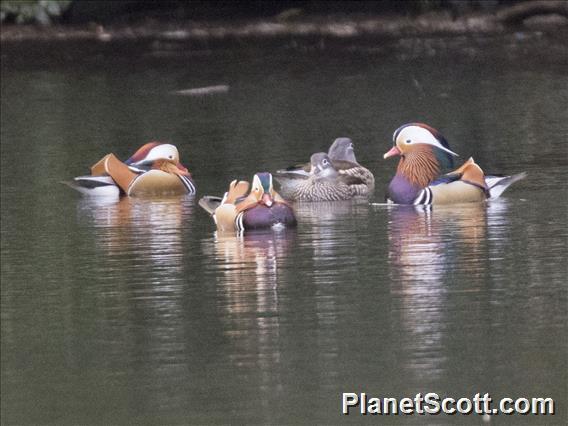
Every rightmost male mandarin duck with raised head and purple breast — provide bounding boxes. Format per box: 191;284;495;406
384;123;526;205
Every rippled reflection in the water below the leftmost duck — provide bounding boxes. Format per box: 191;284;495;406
78;196;194;412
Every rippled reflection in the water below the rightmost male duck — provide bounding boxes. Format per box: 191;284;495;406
388;200;507;380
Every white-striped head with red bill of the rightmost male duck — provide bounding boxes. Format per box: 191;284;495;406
384;123;458;168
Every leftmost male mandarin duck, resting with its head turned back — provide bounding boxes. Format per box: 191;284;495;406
70;142;195;196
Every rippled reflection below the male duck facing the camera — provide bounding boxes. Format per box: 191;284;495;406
204;229;296;400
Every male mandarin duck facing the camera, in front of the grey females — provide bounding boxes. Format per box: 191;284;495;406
199;172;296;232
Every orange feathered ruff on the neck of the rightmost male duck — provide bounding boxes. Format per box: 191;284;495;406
396;147;440;188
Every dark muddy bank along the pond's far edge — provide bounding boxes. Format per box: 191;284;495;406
0;2;568;43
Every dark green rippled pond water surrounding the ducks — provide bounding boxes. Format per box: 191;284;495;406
1;37;568;425
